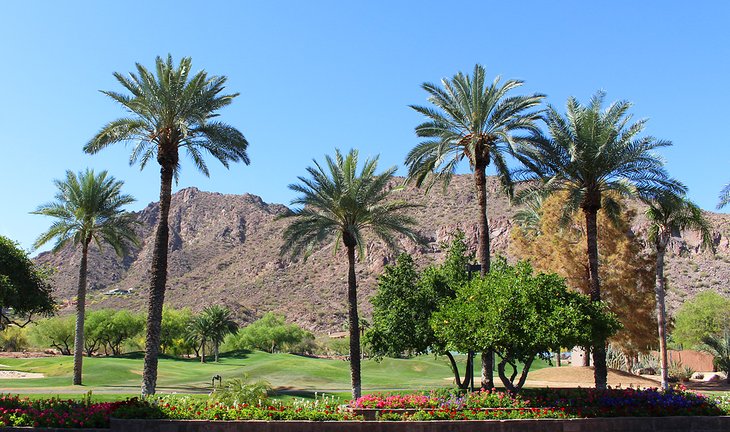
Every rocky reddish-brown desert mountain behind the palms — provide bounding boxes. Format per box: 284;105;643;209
37;176;730;331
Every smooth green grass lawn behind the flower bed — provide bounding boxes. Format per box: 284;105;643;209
0;351;547;397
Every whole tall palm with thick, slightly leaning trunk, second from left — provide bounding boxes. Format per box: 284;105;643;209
84;55;249;395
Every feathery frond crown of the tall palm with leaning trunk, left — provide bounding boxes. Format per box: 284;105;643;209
84;55;250;179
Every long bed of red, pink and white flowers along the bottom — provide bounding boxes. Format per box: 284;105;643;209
0;388;730;428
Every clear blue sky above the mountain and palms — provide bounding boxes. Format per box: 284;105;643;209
0;1;730;253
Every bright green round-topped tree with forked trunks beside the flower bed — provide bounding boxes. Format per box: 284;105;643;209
431;260;619;392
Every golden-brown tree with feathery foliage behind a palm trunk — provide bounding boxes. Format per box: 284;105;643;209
510;193;657;359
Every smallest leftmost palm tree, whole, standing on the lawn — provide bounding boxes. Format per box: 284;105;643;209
33;170;139;385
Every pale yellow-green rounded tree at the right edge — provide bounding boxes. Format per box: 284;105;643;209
671;291;730;348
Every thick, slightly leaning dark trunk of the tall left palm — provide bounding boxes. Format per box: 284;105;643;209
142;162;174;396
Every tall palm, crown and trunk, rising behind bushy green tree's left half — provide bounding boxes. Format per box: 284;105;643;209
406;64;545;388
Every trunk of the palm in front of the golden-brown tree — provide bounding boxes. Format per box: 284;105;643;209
583;207;608;389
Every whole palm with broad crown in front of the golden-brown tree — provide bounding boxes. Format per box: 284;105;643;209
518;92;683;388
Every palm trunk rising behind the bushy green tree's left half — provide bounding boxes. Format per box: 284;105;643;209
474;161;494;389
